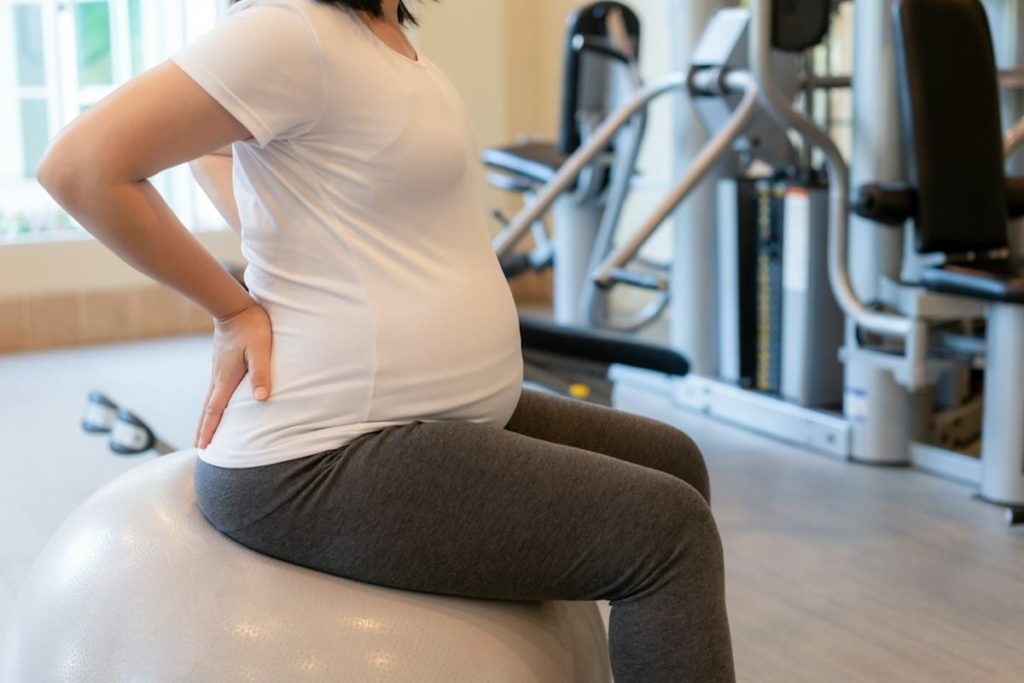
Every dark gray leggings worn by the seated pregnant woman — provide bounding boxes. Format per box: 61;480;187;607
196;390;734;683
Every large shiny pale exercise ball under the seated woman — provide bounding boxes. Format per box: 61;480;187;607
0;451;611;683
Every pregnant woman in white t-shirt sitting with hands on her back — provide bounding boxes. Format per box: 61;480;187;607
39;0;733;683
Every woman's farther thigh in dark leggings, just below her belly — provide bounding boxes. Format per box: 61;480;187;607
505;389;710;500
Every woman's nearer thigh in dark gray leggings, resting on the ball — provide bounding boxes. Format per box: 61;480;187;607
210;422;722;600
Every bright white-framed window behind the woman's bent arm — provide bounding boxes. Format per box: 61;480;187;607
0;0;227;242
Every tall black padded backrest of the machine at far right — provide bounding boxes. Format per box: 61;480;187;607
893;0;1009;253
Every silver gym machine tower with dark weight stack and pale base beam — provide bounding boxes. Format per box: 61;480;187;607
595;0;869;457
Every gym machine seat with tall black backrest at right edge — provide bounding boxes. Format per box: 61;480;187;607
855;0;1024;508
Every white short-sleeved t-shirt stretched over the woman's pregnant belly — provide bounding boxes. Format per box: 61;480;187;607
173;0;522;467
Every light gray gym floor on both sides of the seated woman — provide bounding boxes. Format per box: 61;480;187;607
0;335;1024;683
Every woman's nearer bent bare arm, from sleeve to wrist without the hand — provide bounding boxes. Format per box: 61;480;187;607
38;61;253;319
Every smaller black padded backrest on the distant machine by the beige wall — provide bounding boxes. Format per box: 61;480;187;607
558;0;640;155
